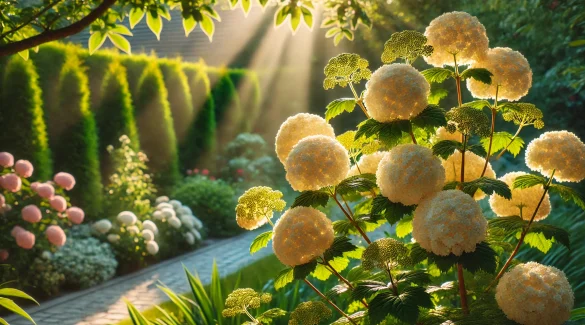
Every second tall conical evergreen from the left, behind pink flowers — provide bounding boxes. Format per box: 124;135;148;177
52;56;102;217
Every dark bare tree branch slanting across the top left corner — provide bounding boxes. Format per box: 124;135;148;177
0;0;116;57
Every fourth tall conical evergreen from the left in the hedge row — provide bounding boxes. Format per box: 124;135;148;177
134;61;179;192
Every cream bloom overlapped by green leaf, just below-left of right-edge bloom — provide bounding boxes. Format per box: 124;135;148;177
490;172;550;221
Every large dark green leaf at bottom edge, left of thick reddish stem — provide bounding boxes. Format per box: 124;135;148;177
368;287;434;324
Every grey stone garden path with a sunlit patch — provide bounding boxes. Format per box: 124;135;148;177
6;231;272;325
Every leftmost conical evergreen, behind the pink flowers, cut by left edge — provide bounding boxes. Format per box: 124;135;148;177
0;55;52;180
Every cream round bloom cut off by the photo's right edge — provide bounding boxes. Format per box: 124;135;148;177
526;131;585;182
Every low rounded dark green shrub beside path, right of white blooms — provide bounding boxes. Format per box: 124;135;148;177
172;176;240;237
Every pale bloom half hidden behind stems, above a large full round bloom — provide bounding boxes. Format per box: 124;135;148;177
443;150;496;200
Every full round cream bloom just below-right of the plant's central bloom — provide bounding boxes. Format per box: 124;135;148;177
412;190;487;256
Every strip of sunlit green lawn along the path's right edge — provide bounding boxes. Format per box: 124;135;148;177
116;255;284;325
